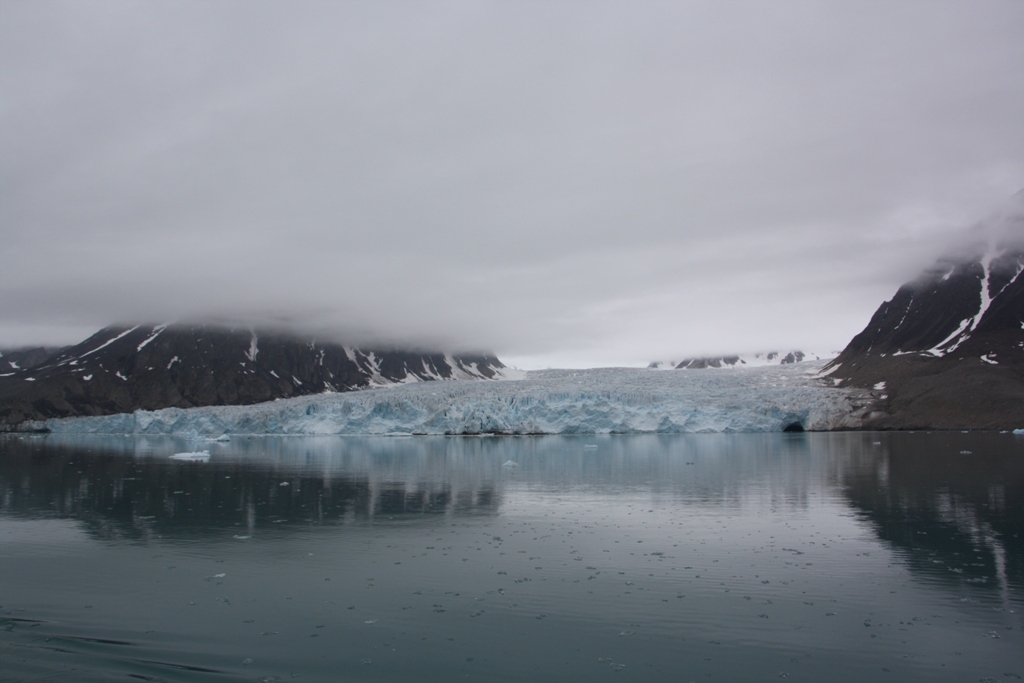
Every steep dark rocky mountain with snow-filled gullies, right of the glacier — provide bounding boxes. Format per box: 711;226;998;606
822;203;1024;429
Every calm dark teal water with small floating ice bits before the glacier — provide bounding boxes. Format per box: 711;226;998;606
0;433;1024;682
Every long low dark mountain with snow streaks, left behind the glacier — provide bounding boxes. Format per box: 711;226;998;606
0;325;505;429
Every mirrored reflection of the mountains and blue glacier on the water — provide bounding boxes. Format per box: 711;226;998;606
0;433;1024;588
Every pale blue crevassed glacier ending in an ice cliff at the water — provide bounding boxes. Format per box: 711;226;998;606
38;362;863;438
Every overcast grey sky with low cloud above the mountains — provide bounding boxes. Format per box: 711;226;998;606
0;0;1024;368
